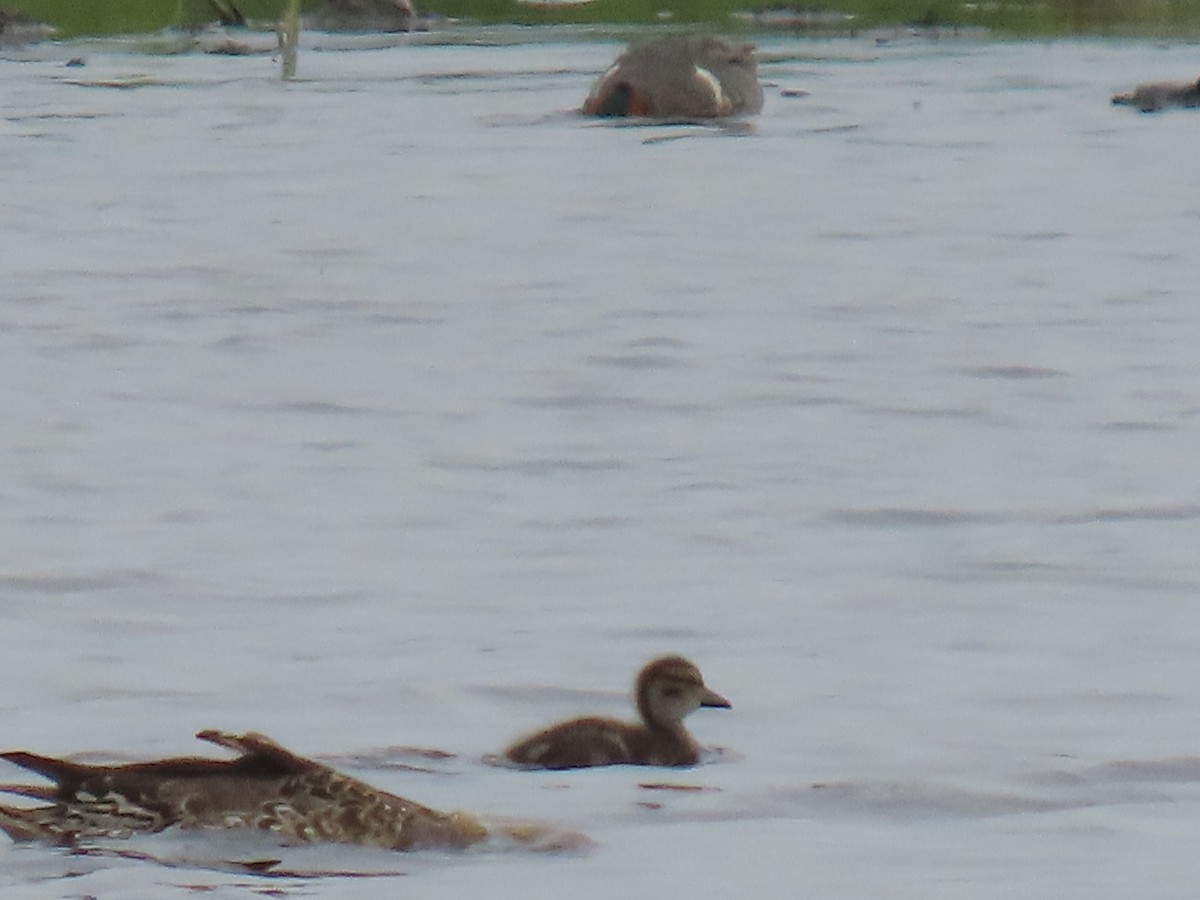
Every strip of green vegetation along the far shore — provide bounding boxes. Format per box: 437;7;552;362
11;0;1200;37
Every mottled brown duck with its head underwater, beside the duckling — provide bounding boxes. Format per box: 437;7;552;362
0;731;487;850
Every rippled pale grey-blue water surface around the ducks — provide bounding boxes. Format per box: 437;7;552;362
0;24;1200;900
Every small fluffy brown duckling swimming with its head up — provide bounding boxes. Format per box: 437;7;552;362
504;656;730;769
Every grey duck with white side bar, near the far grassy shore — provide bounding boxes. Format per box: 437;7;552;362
583;35;762;119
